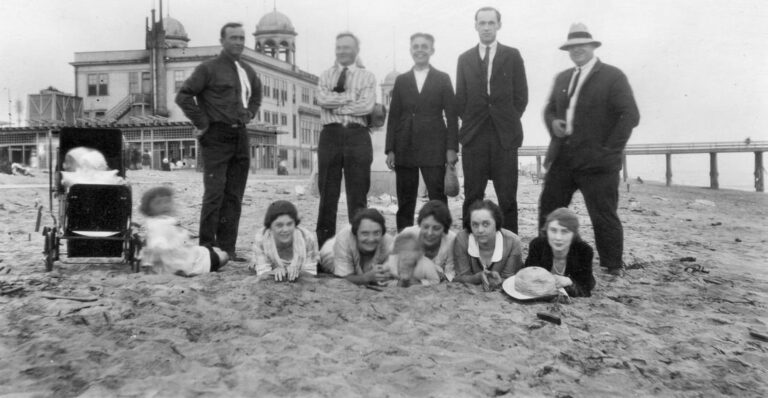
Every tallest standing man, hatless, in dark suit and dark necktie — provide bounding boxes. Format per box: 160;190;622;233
456;7;528;233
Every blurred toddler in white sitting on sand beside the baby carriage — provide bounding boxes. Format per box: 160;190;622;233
139;186;229;276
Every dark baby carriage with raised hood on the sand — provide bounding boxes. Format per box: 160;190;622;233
43;128;140;272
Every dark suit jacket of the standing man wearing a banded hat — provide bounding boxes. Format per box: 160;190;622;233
544;60;640;172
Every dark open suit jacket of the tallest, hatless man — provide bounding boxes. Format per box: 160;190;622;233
456;43;528;149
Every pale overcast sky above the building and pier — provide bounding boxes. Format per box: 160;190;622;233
0;0;768;145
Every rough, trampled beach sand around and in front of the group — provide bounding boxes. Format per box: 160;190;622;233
0;170;768;397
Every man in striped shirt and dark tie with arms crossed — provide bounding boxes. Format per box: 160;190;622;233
316;32;376;246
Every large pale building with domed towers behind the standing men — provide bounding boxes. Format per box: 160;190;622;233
63;4;321;174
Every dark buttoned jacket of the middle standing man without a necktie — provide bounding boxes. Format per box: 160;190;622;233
384;66;459;167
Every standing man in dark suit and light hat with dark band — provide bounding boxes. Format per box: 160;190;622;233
539;23;640;275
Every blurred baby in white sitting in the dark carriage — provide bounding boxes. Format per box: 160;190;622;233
61;146;125;188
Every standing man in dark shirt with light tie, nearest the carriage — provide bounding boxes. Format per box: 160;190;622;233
176;22;262;261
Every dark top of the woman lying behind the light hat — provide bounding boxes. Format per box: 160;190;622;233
525;237;595;297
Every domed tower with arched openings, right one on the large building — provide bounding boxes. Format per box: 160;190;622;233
253;9;297;65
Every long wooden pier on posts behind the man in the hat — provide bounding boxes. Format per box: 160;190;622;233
518;140;768;192
